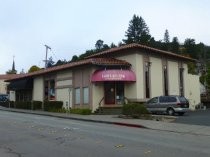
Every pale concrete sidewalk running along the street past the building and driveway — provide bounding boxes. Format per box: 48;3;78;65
0;107;210;136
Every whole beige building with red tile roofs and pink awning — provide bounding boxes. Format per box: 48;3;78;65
8;44;200;111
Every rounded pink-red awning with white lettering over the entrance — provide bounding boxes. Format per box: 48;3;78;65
91;69;136;82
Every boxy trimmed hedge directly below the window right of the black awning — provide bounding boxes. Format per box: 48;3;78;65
44;101;63;111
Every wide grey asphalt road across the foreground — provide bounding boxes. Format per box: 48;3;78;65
0;111;210;157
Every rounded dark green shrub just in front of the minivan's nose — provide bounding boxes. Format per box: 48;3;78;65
122;103;149;118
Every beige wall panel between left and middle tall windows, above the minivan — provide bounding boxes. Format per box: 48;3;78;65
150;57;163;97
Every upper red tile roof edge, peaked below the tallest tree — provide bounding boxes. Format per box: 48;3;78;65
86;43;196;61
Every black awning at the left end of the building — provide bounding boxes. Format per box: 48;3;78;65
7;79;33;90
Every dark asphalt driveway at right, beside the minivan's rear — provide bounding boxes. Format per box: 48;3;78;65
175;109;210;126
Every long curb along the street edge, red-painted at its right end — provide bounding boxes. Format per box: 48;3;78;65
0;107;149;129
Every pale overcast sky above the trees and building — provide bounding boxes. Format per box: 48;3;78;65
0;0;210;74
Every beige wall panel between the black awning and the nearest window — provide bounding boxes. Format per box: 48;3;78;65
33;76;44;101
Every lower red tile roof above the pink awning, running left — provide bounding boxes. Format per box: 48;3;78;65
6;58;131;82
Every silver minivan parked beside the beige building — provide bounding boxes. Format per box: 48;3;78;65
145;95;189;115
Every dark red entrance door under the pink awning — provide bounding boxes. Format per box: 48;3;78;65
104;82;115;104
